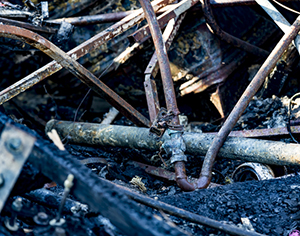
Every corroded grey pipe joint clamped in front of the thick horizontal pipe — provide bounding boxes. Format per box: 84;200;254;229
162;129;187;163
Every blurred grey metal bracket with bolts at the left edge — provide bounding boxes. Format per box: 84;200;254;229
0;124;36;213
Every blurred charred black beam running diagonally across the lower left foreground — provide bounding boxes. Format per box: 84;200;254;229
0;113;186;236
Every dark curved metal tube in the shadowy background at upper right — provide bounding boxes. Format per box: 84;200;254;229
202;0;269;58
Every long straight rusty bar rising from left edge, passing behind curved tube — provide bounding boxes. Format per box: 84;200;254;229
0;0;174;105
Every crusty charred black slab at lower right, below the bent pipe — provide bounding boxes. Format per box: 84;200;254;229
159;176;300;235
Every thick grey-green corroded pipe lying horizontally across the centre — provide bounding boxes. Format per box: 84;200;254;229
46;120;300;166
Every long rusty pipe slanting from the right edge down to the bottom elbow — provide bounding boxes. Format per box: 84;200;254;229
197;14;300;188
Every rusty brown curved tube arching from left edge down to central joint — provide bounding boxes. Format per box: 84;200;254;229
0;25;150;127
